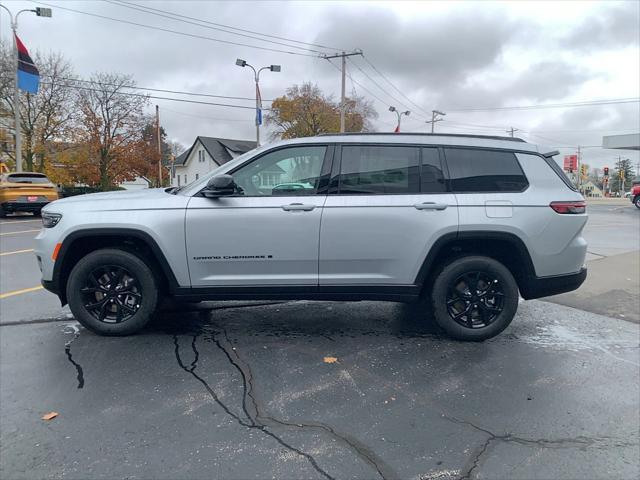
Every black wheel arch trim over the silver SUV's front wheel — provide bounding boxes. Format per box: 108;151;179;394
52;228;178;305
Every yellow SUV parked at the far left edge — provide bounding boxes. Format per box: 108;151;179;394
0;172;58;217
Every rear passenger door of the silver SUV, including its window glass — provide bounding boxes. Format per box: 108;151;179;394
319;144;458;287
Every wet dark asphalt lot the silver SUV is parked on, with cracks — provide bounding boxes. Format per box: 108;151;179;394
0;205;640;479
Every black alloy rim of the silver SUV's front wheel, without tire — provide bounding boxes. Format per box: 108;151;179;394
80;265;143;323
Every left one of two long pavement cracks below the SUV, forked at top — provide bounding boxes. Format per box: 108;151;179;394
173;334;335;480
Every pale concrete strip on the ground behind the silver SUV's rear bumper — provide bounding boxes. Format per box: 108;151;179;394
543;250;640;323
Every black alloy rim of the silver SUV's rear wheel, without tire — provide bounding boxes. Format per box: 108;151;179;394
447;271;505;329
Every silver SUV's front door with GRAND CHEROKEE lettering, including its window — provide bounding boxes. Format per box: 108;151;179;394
186;145;328;287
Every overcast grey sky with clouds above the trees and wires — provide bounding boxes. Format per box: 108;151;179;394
0;0;640;167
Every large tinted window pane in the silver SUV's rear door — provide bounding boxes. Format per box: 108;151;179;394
340;146;420;194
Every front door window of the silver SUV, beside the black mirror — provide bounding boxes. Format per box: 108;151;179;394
233;146;327;196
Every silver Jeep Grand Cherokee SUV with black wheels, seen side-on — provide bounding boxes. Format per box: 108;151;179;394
35;134;587;340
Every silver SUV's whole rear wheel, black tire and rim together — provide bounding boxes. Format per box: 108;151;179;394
431;256;518;341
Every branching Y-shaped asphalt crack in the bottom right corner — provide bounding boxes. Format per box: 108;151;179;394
452;415;637;480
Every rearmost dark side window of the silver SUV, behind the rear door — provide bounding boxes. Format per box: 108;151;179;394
445;148;528;192
